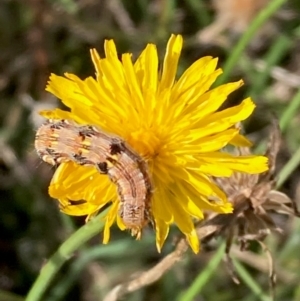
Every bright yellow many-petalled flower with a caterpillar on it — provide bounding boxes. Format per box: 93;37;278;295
42;35;267;252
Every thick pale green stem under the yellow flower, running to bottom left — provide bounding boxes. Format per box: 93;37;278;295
25;211;106;301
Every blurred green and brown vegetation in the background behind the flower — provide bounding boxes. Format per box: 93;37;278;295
0;0;300;301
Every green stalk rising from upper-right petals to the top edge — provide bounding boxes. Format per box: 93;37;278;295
216;0;287;85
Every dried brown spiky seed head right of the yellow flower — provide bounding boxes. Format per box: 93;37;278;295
215;122;299;287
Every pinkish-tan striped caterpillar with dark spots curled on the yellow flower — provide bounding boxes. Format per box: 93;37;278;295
35;120;153;238
